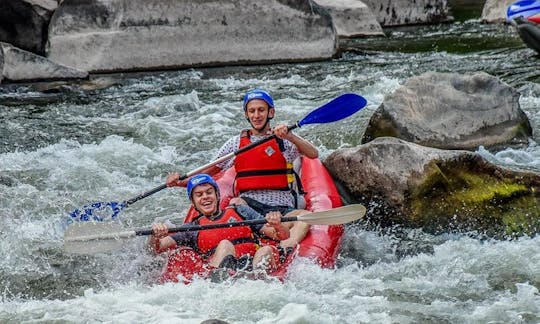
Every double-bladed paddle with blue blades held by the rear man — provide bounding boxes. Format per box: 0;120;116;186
69;93;367;221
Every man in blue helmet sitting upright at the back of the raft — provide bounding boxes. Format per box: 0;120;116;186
167;89;318;250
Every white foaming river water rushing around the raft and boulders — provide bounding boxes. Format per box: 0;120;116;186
0;21;540;323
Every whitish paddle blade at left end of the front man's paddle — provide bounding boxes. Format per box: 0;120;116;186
64;222;136;254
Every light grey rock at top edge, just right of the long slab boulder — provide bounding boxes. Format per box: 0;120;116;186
315;0;384;37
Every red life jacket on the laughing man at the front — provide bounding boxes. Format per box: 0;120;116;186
196;208;259;256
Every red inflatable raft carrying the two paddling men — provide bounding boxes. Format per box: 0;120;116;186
160;157;344;283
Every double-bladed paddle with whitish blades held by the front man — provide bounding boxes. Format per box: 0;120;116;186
64;204;366;254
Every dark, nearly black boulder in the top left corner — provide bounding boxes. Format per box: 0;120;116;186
0;0;57;55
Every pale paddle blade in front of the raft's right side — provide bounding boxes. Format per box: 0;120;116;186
298;204;366;225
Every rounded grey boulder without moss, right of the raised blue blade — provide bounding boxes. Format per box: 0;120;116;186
362;72;532;150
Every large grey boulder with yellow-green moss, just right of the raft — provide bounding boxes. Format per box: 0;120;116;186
324;137;540;237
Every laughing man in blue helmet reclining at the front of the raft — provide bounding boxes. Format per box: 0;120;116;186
149;174;290;280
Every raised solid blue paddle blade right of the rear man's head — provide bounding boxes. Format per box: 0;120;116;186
297;93;367;127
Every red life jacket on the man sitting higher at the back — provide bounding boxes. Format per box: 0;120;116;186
234;130;294;195
